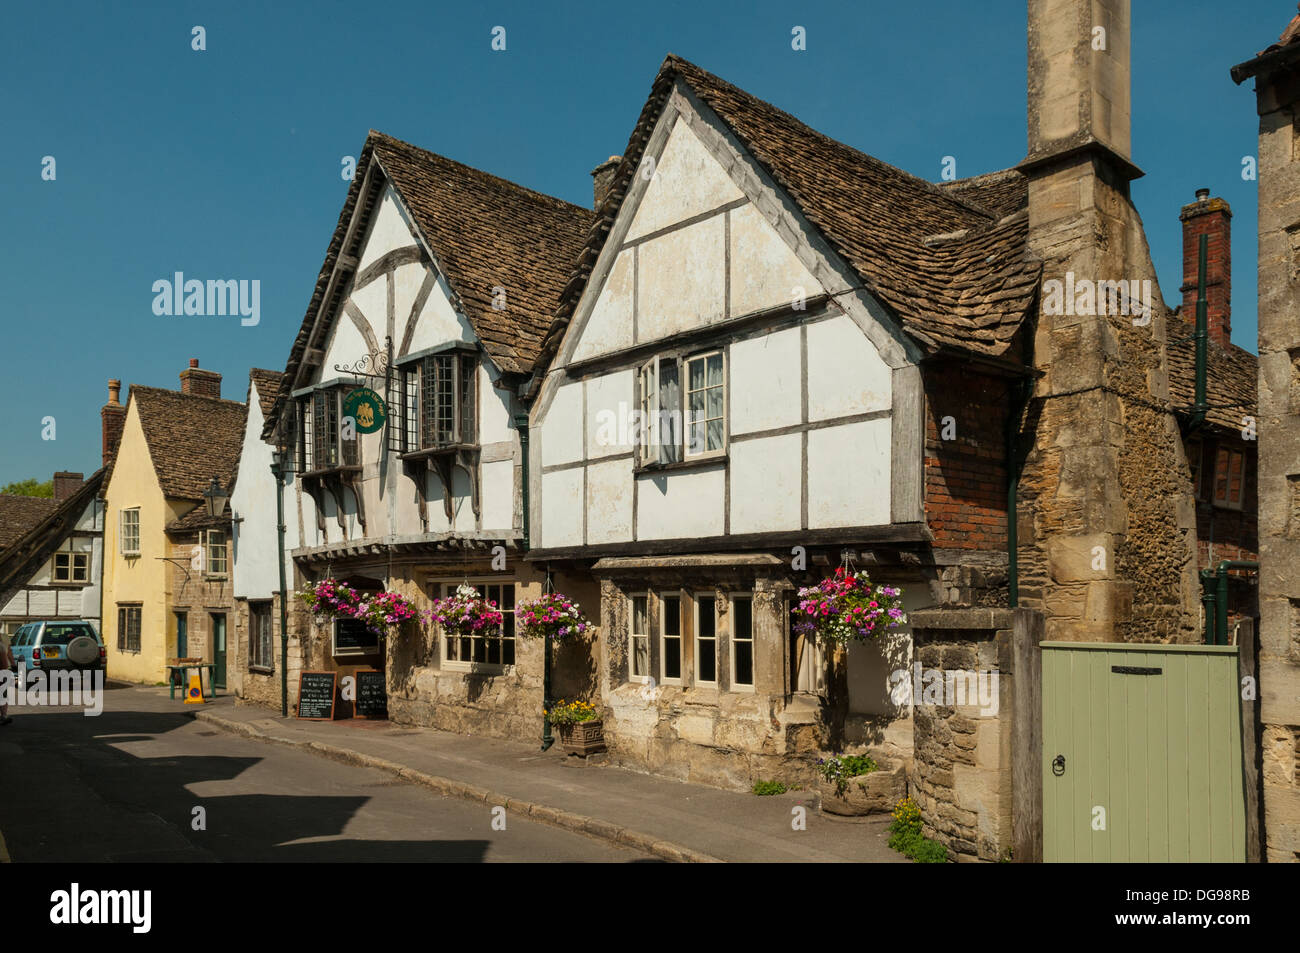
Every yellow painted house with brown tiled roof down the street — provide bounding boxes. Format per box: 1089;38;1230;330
103;360;247;684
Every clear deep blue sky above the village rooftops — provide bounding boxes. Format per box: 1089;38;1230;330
0;0;1295;485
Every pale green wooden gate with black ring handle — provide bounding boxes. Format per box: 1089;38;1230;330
1041;642;1245;862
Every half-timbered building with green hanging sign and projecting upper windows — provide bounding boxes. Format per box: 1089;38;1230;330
260;131;594;737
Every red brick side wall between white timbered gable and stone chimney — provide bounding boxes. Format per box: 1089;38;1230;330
924;363;1010;550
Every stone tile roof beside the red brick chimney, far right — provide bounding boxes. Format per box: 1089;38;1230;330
1169;313;1260;432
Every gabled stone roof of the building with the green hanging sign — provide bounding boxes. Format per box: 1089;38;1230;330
263;130;594;437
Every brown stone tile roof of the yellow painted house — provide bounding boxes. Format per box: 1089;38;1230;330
127;385;248;501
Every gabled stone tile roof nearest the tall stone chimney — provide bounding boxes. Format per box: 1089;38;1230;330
533;55;1041;374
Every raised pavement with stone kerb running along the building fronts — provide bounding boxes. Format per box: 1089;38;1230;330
189;689;909;863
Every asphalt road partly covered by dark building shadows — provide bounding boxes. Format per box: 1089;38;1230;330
0;685;650;863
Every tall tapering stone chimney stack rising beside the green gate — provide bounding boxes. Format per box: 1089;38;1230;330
1017;0;1200;642
